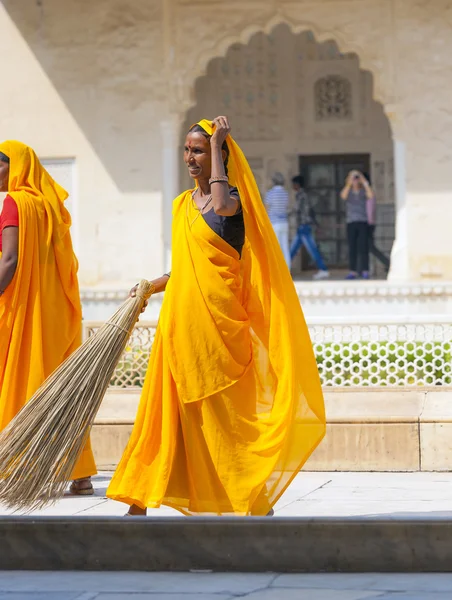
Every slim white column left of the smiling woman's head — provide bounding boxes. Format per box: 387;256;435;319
160;114;183;272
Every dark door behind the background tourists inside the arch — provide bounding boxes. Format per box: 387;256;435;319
299;154;370;270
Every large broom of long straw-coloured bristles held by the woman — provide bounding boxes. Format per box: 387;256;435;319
0;280;155;511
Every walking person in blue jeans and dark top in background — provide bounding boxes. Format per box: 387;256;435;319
290;175;330;279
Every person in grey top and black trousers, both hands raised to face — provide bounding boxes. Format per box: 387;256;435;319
341;171;374;279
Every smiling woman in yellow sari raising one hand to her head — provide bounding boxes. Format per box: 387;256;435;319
107;117;325;515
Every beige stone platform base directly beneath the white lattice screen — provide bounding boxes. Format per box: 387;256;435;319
91;388;452;471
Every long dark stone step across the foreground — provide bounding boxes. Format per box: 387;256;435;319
0;516;452;573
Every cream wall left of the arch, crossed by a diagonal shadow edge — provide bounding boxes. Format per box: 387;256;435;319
0;0;165;287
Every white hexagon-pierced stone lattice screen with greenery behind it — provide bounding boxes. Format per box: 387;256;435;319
85;323;452;388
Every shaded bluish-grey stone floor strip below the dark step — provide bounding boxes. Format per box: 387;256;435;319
0;571;452;600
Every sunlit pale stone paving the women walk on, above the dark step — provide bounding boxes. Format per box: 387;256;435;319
0;472;452;516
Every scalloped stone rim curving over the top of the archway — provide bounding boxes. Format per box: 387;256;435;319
175;13;394;116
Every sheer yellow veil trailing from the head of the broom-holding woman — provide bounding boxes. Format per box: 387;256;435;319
198;120;326;504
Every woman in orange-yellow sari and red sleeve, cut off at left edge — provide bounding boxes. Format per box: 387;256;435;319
0;141;96;495
